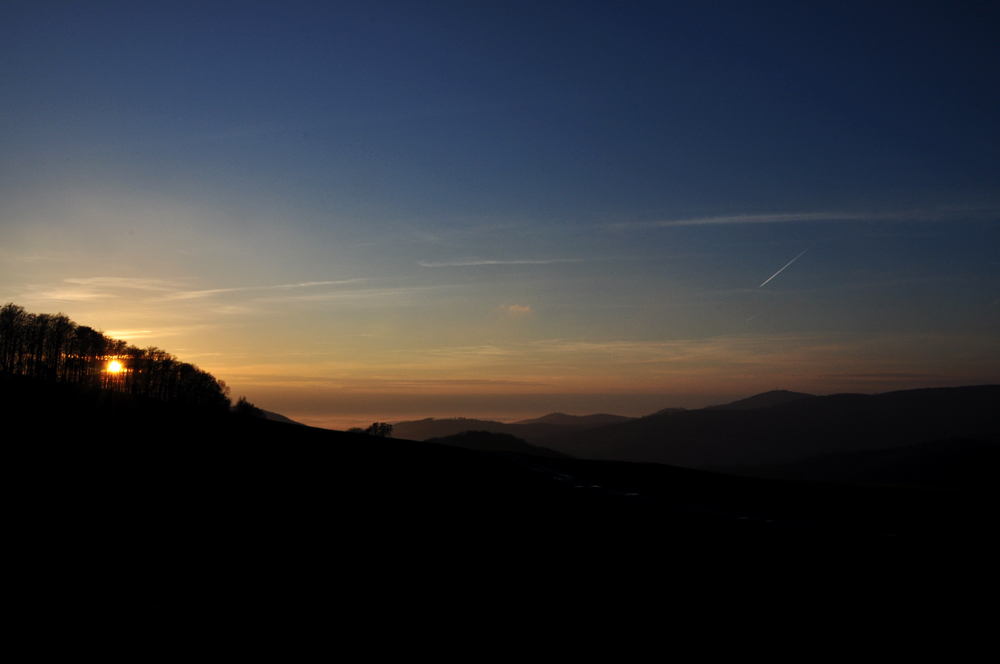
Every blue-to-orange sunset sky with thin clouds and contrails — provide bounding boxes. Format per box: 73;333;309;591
0;1;1000;428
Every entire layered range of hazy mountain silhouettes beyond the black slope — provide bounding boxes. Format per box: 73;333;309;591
395;385;1000;491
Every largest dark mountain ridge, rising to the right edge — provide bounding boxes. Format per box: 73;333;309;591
536;385;1000;468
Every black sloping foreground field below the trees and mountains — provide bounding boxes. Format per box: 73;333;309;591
0;377;997;658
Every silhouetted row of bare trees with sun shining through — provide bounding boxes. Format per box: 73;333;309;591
0;302;230;410
